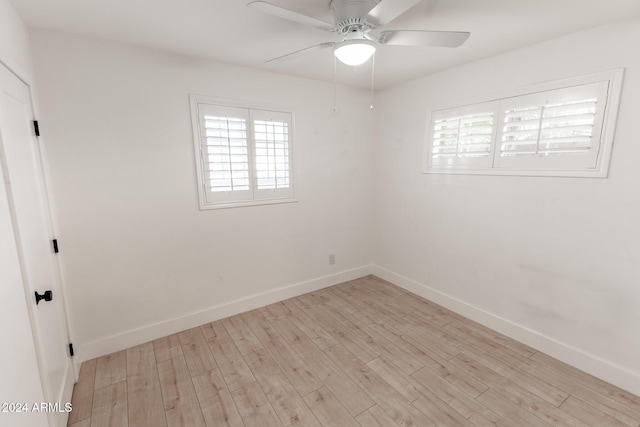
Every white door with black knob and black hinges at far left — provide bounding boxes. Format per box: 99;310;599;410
0;61;73;426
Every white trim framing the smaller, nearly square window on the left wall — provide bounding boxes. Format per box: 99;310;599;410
189;94;298;210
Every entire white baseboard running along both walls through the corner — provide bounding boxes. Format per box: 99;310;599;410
74;264;640;395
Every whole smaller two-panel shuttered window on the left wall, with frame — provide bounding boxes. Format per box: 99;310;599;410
190;95;295;209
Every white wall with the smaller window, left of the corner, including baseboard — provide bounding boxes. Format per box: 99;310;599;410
32;31;373;360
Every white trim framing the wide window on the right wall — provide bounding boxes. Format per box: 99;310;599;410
422;68;624;178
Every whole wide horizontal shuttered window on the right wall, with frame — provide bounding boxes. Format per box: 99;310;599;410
425;70;622;177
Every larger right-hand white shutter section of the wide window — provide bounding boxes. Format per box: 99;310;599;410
495;82;608;170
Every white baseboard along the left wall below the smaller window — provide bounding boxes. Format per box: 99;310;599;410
74;265;371;374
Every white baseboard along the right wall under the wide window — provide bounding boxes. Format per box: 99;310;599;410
371;264;640;396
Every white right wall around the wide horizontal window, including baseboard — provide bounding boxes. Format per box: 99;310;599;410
373;19;640;394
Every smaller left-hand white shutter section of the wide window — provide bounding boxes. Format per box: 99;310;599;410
429;103;495;168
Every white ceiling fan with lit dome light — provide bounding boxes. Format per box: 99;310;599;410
248;0;470;66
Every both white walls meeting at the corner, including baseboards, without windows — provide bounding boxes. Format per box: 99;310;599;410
32;15;640;394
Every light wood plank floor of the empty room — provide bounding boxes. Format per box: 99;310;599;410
69;276;640;427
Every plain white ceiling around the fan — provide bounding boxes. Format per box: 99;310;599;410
10;0;640;88
